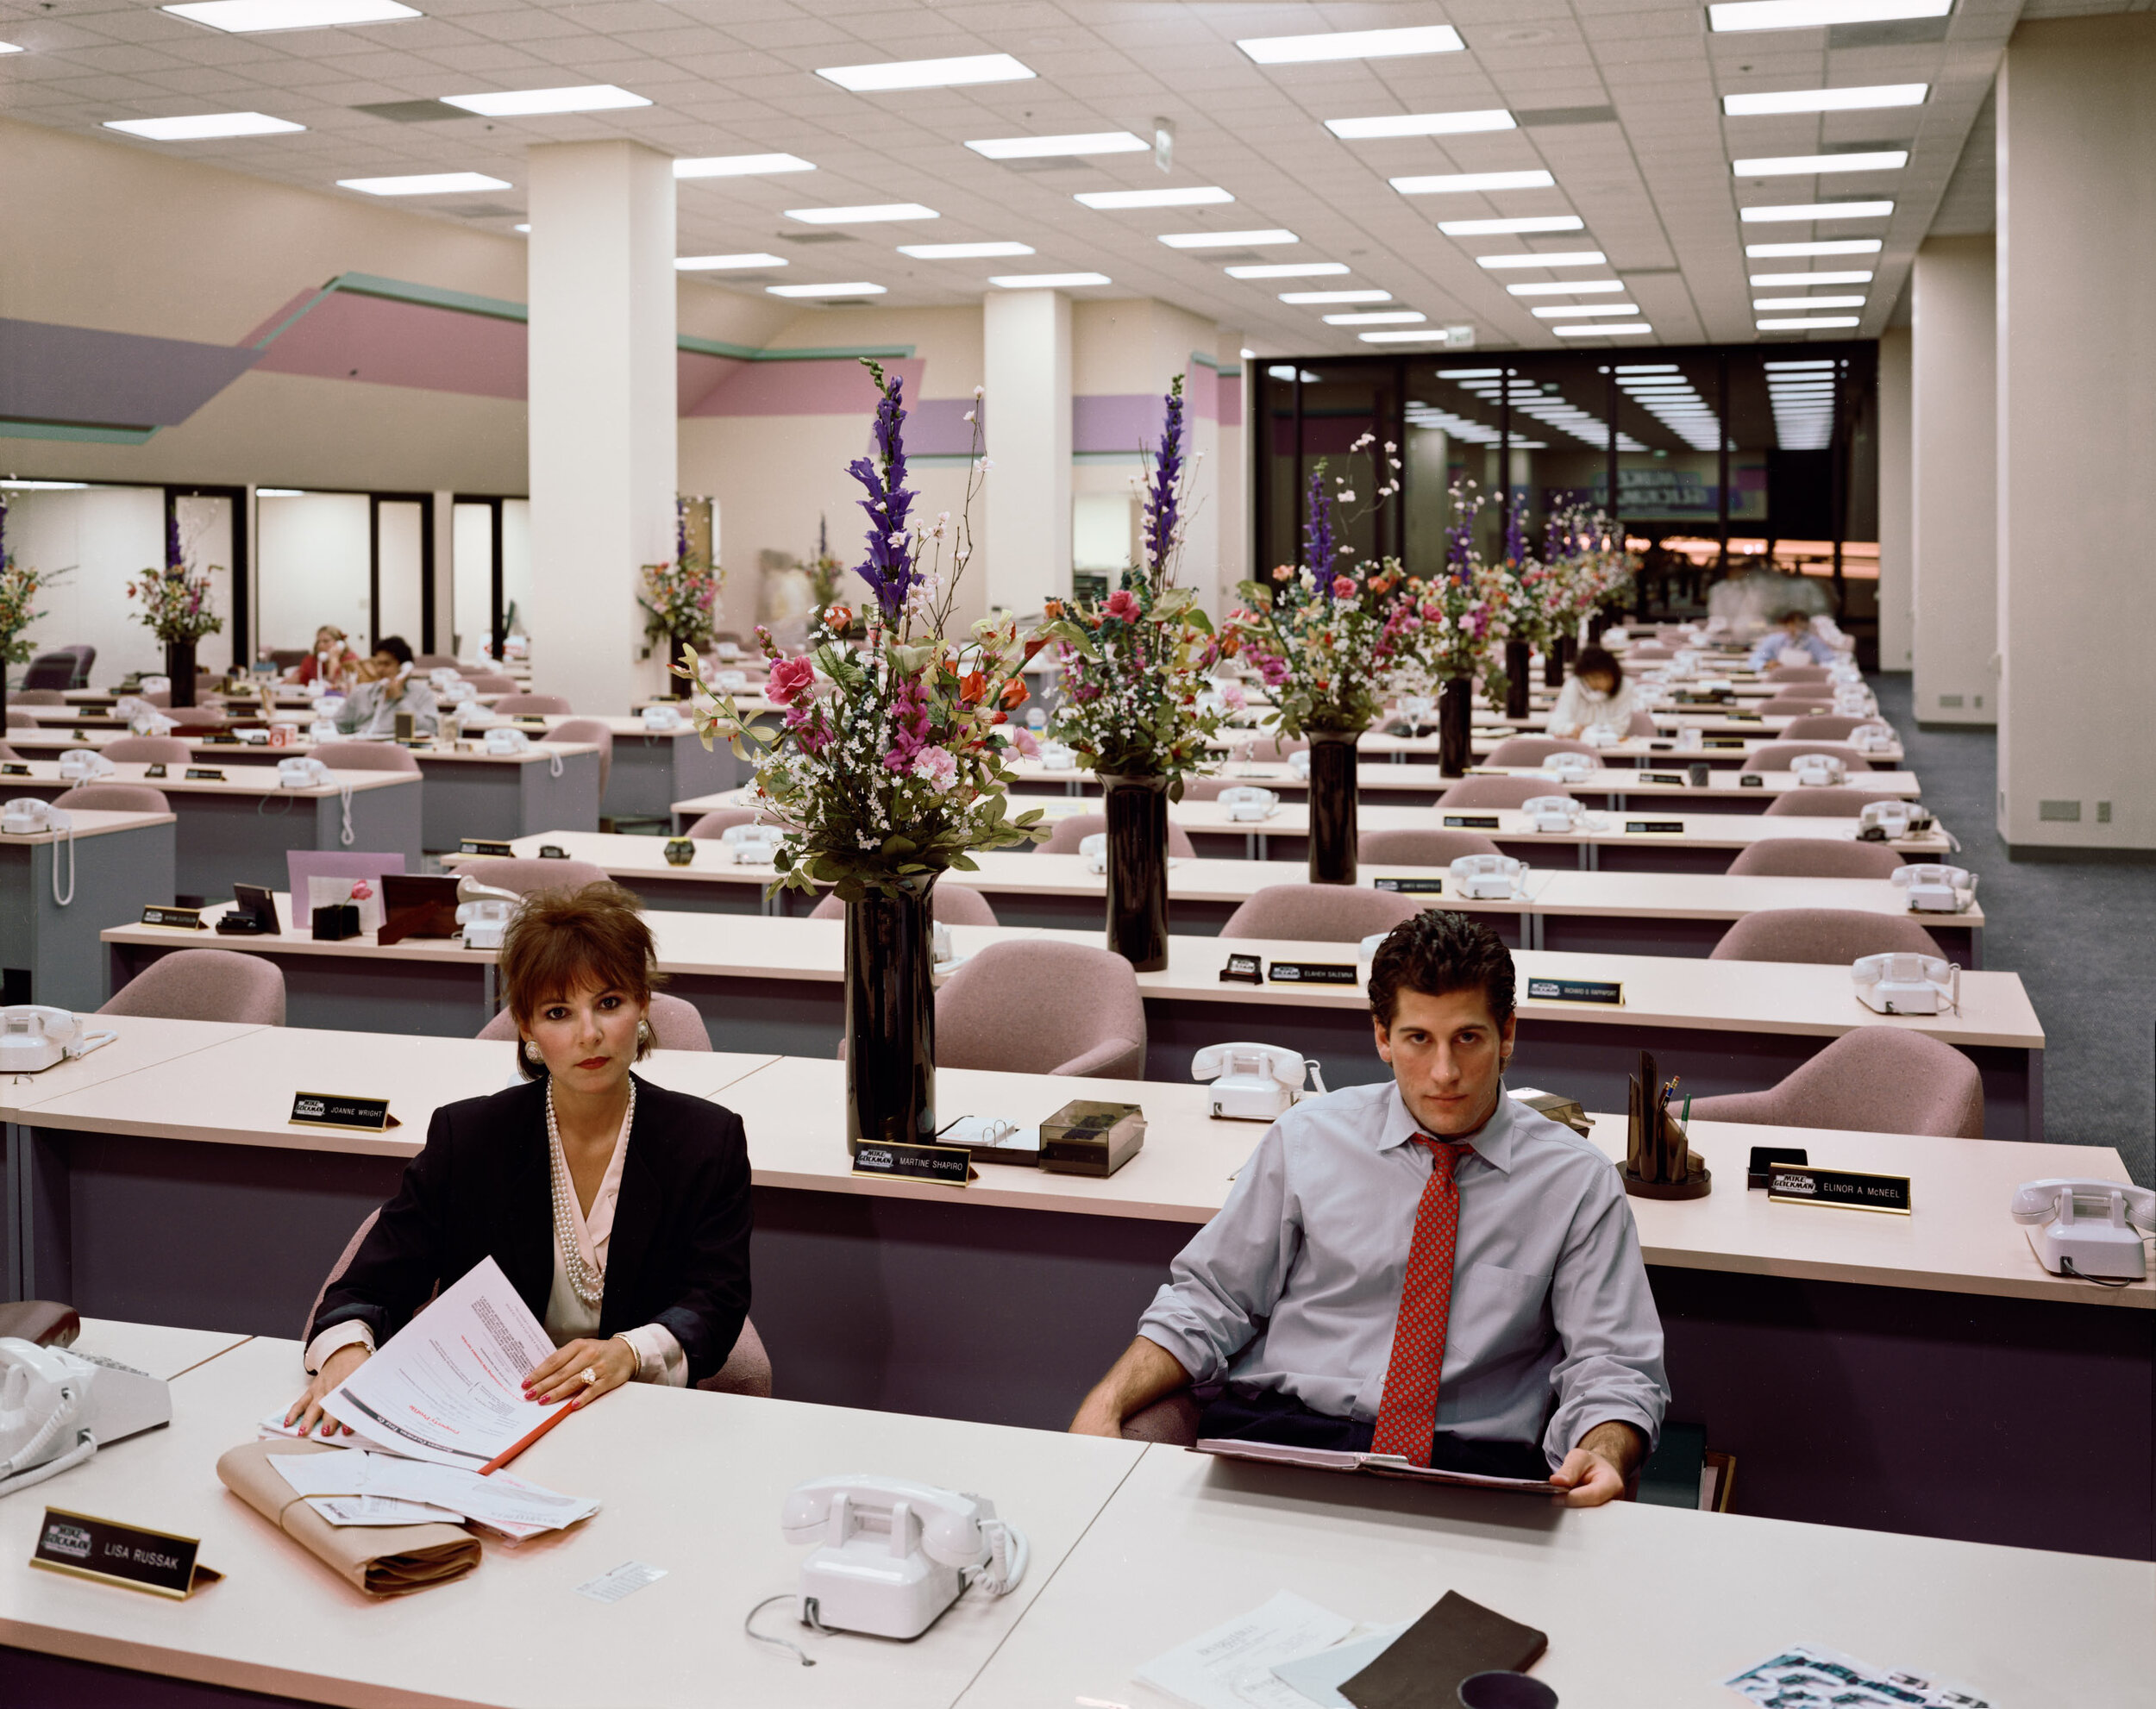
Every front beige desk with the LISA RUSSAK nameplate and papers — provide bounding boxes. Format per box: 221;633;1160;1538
0;1341;1143;1709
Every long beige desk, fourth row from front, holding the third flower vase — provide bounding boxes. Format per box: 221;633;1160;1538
442;832;1984;967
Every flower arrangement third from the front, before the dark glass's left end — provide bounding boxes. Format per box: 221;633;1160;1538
1223;433;1414;737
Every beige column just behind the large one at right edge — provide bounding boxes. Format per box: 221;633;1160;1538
1915;235;1999;724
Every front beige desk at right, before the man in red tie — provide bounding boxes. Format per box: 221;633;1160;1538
960;1446;2156;1709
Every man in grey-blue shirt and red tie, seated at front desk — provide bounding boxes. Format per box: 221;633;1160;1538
1072;910;1669;1506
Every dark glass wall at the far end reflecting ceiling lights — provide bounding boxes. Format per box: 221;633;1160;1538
1250;342;1878;653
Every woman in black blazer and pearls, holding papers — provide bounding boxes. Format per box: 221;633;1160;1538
285;884;750;1433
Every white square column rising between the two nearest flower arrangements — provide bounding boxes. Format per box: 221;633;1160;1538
981;291;1072;617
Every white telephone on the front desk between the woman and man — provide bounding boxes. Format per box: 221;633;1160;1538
779;1476;1031;1638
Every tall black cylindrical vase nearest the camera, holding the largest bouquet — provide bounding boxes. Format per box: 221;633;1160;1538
845;880;936;1155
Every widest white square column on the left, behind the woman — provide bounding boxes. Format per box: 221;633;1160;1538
526;140;677;716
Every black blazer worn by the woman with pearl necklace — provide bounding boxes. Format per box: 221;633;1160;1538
309;1078;750;1384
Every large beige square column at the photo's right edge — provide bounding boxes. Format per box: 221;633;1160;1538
1992;13;2156;851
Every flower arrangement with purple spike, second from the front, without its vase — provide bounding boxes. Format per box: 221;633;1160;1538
1044;375;1240;799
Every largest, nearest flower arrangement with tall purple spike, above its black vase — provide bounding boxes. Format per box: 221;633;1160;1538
675;358;1048;903
